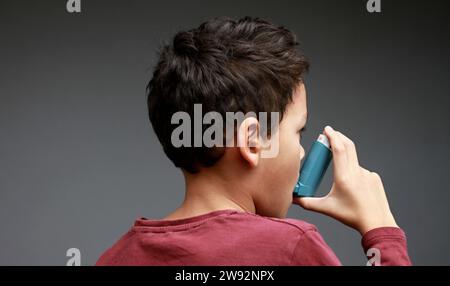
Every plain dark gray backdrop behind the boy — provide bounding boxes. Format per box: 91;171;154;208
0;0;450;265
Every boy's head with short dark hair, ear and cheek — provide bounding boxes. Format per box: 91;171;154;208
148;17;309;217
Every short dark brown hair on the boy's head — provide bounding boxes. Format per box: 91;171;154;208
147;17;309;173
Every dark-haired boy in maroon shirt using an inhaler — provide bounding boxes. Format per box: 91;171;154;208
97;17;410;265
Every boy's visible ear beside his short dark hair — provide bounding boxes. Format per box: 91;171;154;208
237;117;261;167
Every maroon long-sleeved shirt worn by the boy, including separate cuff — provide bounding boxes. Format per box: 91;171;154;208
96;210;411;265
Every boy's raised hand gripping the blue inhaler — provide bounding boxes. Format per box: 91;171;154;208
293;126;398;235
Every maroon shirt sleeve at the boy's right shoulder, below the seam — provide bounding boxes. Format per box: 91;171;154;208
292;229;341;266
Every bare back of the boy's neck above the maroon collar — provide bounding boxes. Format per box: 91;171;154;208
164;170;255;220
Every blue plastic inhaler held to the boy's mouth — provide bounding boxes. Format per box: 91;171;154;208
294;134;333;197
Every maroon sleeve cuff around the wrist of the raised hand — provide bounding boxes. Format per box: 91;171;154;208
361;227;411;266
